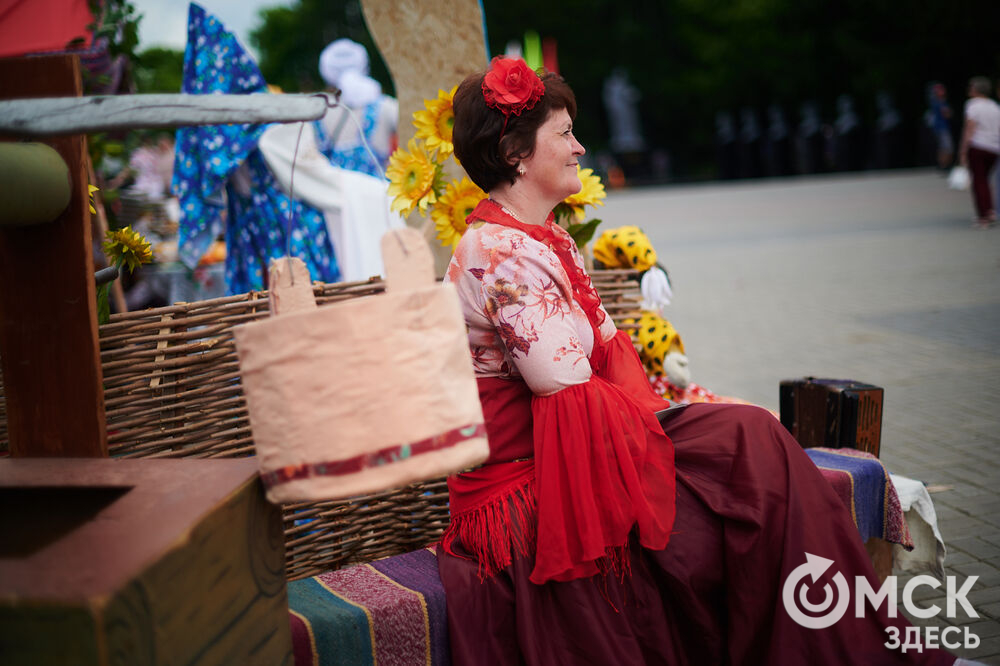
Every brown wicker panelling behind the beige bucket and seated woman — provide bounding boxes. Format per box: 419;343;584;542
0;270;639;580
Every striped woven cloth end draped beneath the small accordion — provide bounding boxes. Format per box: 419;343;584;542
806;448;913;550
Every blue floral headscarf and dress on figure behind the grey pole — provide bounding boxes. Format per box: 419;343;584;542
173;3;340;294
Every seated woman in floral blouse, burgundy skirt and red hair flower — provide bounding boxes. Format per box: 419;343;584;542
439;58;955;666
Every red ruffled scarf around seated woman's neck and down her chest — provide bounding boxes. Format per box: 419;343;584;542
466;199;605;332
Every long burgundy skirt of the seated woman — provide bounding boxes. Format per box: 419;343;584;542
438;404;955;666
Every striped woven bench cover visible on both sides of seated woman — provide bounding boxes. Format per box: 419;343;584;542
288;448;913;666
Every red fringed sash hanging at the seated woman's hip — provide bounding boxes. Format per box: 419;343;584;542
441;478;538;581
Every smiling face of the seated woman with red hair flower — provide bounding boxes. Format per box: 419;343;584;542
520;109;586;206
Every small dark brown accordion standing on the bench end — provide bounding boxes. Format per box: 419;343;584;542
779;377;884;457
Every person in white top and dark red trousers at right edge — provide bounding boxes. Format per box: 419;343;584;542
959;76;1000;229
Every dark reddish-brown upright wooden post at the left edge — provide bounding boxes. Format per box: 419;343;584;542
0;55;108;457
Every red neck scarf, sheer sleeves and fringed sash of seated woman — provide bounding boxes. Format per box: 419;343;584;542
442;200;674;584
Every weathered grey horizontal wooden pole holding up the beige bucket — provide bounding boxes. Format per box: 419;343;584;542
0;93;335;136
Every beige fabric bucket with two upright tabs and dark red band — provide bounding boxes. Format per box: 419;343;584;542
234;228;489;502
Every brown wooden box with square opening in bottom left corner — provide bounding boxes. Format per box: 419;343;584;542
0;458;292;666
